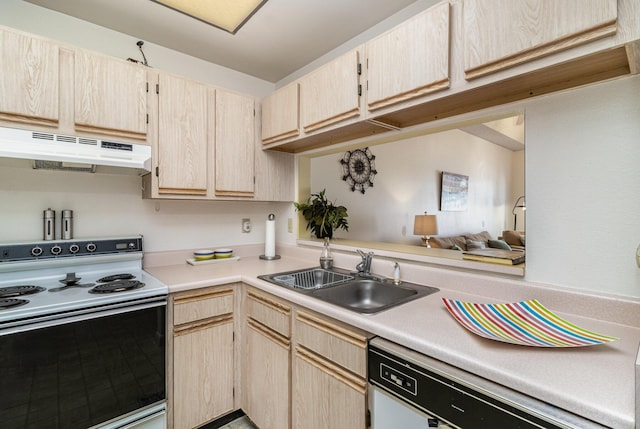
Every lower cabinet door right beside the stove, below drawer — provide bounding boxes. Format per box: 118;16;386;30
173;316;234;429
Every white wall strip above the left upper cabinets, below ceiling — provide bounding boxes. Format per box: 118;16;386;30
0;0;274;97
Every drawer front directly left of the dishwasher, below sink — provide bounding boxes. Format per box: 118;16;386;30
296;311;367;377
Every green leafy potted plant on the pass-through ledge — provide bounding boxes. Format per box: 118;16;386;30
293;189;349;238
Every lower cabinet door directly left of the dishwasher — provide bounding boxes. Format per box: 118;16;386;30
293;348;367;429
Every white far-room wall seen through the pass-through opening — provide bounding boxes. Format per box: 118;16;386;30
311;130;524;244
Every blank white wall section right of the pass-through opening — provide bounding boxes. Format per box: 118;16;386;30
525;76;640;297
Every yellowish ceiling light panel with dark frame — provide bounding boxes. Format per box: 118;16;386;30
151;0;267;34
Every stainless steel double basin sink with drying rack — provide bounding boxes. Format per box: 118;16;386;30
258;268;438;314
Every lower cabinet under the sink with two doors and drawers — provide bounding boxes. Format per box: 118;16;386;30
242;285;370;429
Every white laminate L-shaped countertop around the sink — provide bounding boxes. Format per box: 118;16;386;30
145;246;640;429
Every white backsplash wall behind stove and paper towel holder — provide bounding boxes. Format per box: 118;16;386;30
0;160;295;251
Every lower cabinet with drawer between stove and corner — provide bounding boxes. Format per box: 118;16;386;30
167;285;235;429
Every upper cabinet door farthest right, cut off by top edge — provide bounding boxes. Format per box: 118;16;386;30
463;0;618;79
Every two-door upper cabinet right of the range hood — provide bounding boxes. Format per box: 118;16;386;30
142;71;294;201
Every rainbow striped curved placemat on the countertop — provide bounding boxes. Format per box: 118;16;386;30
442;298;619;347
